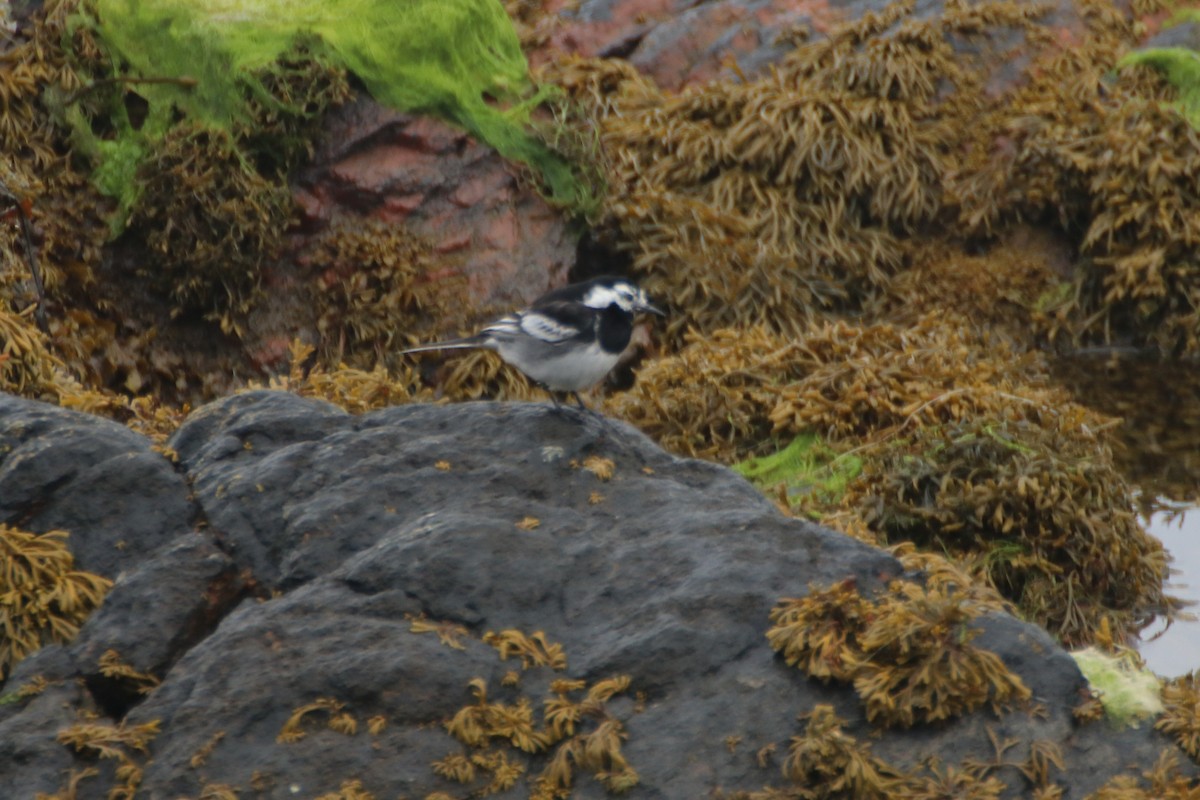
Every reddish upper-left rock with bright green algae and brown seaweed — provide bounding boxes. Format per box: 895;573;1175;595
0;0;578;405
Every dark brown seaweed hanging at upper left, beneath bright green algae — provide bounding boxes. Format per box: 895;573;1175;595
0;0;349;395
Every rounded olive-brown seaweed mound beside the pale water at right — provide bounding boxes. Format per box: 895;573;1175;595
844;417;1176;644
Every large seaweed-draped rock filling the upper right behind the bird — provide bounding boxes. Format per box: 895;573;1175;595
545;0;1198;354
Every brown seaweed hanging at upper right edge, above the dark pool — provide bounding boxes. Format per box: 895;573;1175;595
956;1;1200;355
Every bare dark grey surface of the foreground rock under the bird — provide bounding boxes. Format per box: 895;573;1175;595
0;392;1187;799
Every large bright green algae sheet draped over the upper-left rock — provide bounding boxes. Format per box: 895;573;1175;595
64;0;584;212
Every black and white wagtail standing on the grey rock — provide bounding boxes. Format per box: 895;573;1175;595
401;276;665;409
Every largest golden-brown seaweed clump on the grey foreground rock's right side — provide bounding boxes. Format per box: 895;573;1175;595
767;581;1030;727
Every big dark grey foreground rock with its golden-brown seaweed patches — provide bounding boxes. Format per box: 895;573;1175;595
0;392;1194;800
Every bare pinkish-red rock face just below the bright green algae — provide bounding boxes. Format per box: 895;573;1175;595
288;98;575;308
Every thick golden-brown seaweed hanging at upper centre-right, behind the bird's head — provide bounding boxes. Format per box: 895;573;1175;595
547;2;1038;342
